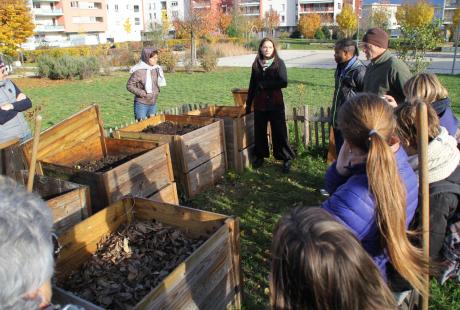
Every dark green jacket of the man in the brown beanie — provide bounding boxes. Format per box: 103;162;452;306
364;50;412;104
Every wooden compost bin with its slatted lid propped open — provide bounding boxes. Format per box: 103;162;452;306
23;105;174;212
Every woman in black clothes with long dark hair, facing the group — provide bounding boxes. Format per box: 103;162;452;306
246;38;294;173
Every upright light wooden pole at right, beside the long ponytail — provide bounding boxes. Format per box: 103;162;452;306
417;101;430;310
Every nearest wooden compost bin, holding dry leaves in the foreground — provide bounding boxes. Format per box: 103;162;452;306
56;198;241;310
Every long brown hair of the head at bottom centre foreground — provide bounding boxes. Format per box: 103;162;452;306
270;208;396;310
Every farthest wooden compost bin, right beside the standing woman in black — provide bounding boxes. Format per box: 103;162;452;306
187;106;254;172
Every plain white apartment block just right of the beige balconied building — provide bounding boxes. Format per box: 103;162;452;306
106;0;144;42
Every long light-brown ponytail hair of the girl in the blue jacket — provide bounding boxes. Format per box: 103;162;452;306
338;93;428;294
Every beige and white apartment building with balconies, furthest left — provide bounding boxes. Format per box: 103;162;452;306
24;0;107;49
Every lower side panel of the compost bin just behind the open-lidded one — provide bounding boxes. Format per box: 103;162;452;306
185;154;225;198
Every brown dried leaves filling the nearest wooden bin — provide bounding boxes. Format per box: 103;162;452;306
58;220;204;309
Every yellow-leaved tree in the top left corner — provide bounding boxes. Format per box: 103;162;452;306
0;0;35;56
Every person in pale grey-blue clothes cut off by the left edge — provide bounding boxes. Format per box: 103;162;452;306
0;60;32;143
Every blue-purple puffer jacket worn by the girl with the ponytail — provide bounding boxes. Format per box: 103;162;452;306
322;147;418;279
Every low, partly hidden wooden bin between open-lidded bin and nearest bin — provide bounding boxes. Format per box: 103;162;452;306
15;170;91;235
